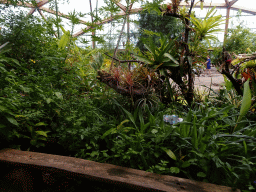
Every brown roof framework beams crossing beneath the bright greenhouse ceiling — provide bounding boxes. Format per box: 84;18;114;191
0;0;256;47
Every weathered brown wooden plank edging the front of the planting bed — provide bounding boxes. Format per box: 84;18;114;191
0;149;240;192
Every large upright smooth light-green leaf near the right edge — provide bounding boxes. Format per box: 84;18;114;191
237;79;252;122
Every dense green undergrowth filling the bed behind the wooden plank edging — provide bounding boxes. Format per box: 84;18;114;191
0;9;256;191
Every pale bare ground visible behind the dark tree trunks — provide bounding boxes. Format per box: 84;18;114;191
195;67;224;92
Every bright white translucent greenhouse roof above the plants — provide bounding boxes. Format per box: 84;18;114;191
0;0;256;48
